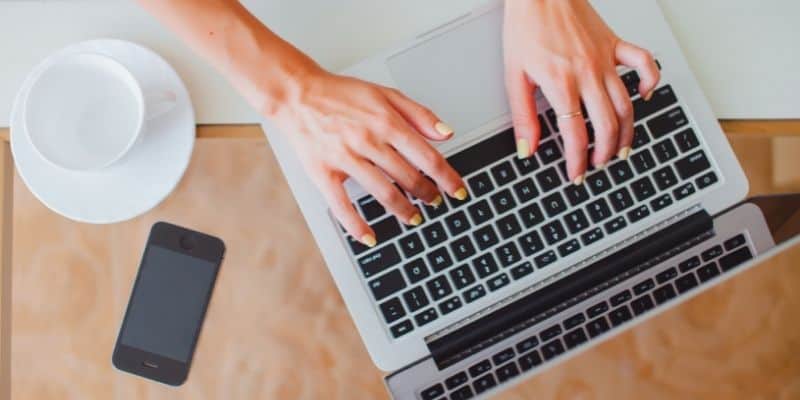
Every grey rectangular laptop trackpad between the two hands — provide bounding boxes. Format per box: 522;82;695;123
387;8;509;133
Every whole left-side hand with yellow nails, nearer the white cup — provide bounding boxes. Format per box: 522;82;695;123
267;68;467;247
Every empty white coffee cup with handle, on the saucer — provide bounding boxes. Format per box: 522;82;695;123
23;53;176;171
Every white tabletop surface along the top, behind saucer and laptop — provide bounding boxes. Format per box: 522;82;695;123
0;0;800;126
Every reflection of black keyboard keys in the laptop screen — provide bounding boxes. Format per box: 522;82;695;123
419;234;753;400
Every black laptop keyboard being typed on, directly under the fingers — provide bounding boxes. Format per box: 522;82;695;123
343;71;718;338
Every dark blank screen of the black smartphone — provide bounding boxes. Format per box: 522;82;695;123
120;245;216;363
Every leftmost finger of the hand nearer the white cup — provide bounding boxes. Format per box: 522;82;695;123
312;167;376;247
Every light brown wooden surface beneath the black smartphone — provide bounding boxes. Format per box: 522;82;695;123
0;121;800;400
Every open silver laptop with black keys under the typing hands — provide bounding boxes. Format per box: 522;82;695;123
263;0;792;400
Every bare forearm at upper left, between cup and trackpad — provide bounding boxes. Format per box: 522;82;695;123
138;0;319;115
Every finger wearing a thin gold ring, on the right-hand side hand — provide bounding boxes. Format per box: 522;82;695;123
539;77;589;185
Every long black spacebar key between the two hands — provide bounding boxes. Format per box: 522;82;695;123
447;129;516;176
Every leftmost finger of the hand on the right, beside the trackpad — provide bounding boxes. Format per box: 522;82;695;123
506;71;541;158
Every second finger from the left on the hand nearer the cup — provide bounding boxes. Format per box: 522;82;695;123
345;158;422;226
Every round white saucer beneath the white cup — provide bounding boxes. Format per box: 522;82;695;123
11;39;195;224
